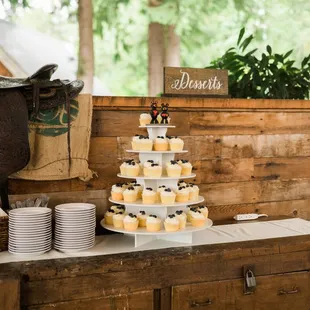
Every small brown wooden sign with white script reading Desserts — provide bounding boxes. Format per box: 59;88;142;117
164;67;228;96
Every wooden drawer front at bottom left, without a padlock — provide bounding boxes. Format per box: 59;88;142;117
27;291;153;310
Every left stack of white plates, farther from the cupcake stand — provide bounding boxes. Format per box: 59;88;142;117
9;207;52;255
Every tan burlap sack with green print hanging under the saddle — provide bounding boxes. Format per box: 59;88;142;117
11;95;93;181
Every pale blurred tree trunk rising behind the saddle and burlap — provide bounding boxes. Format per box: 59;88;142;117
77;0;94;94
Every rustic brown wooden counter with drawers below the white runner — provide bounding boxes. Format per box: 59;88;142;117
0;219;310;310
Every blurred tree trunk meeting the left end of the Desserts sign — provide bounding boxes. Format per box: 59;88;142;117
148;23;165;96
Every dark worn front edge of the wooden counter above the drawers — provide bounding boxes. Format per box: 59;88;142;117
0;235;310;281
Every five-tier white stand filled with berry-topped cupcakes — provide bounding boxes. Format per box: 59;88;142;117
101;109;212;247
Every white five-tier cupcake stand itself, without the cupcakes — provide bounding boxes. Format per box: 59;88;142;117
101;125;213;247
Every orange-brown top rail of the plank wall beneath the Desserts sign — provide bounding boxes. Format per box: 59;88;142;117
93;96;310;111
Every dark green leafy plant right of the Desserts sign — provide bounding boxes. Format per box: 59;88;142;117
209;28;310;99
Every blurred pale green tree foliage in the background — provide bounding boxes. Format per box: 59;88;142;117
0;0;310;96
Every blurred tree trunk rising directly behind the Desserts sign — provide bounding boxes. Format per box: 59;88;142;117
165;25;181;67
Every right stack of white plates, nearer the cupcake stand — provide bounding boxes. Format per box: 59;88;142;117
54;203;96;252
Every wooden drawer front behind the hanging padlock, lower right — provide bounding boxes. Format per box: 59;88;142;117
172;272;310;310
